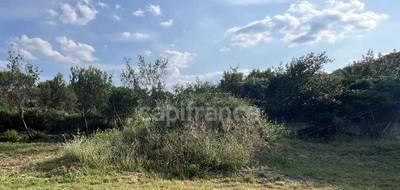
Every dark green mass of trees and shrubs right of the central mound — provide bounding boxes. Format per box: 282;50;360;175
219;51;400;138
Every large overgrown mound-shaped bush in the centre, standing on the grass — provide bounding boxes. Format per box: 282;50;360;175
66;92;280;178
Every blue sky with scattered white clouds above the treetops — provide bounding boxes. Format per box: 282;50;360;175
0;0;400;86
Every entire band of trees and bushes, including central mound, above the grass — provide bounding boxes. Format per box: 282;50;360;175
0;49;400;178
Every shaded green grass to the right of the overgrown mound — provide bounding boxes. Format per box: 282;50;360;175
263;140;400;189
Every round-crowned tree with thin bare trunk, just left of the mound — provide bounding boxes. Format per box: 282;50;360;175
71;66;112;135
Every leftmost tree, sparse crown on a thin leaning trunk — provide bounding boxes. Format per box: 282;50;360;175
0;51;39;138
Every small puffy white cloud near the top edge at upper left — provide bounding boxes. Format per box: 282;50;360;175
59;3;98;26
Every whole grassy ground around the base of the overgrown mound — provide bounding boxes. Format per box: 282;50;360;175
0;140;400;189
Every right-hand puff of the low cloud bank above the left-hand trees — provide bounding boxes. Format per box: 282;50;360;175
57;36;97;62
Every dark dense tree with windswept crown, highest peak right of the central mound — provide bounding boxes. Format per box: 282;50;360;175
264;53;332;121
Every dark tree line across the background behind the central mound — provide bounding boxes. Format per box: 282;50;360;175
0;51;400;138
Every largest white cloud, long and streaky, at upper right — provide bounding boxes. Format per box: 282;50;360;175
227;0;388;47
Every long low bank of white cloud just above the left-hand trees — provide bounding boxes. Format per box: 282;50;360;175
12;34;97;65
